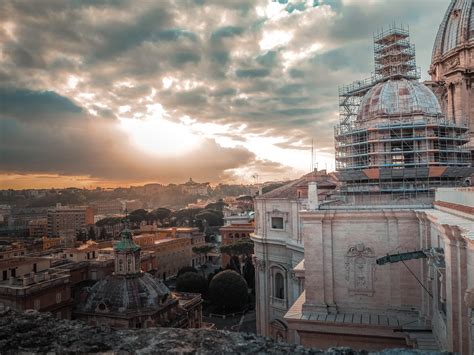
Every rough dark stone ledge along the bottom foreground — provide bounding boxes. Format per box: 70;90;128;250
0;311;446;355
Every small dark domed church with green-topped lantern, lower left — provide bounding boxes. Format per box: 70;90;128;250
74;222;202;328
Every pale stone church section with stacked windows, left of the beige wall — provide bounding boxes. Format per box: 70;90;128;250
251;170;337;341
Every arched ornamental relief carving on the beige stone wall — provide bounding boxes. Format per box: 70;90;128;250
345;242;375;296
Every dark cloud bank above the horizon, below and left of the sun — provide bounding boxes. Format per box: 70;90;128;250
0;90;254;181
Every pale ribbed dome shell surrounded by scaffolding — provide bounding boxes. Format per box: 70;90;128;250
357;79;441;120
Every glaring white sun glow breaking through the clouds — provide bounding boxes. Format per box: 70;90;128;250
120;104;202;156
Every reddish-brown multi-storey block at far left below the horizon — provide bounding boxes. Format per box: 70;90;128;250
47;204;94;237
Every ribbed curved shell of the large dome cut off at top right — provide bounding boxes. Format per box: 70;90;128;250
433;0;474;62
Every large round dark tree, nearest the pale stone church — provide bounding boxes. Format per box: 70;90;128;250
209;270;248;312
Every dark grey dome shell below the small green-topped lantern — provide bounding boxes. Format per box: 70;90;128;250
79;273;171;314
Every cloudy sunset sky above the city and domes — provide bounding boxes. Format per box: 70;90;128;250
0;0;449;189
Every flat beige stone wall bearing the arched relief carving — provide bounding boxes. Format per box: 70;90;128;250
302;210;421;312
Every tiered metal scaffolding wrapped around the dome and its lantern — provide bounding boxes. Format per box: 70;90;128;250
334;25;473;199
